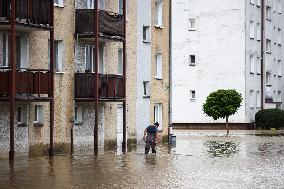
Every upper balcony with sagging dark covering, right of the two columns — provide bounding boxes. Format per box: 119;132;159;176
75;9;124;40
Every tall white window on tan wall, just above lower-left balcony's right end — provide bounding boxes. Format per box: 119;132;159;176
48;40;63;72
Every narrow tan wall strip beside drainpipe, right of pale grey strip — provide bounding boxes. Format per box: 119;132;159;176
150;0;170;139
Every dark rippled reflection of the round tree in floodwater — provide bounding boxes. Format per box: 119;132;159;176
204;141;240;157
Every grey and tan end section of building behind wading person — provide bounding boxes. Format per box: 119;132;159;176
136;0;170;141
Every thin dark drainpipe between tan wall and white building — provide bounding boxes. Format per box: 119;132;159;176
168;0;172;136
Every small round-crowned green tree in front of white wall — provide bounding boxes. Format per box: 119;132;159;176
203;89;243;135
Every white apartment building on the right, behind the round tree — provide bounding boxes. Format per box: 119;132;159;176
171;0;284;125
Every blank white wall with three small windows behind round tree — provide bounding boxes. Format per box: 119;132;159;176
172;0;247;123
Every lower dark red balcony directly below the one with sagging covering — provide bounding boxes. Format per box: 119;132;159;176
75;73;125;101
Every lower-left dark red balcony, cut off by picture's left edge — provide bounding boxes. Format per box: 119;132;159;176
0;68;51;100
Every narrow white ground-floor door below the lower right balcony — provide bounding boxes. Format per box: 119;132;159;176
116;105;123;153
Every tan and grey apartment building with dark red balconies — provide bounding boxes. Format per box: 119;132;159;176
0;0;169;159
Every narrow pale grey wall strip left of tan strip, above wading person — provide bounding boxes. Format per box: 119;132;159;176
136;0;153;141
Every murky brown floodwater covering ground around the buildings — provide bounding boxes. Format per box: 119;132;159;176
0;131;284;189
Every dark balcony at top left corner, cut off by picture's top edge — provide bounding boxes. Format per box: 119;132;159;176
0;0;53;29
